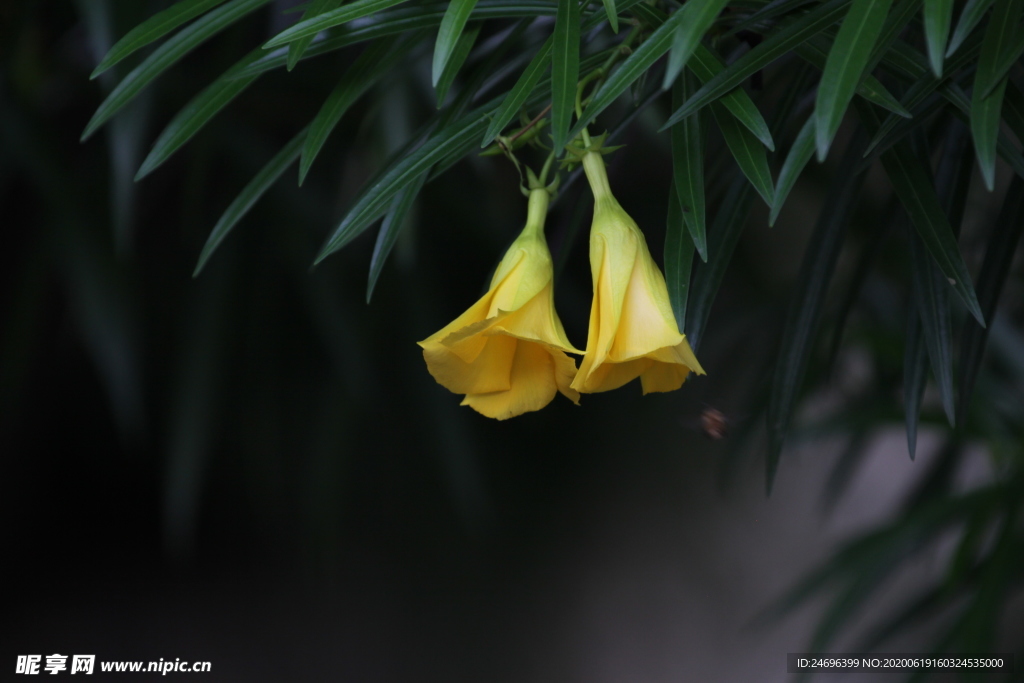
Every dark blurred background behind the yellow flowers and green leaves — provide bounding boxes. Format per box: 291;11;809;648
0;0;1020;682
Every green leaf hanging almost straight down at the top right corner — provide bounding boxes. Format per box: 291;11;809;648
971;0;1024;191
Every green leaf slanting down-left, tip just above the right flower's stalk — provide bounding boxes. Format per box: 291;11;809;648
567;0;721;140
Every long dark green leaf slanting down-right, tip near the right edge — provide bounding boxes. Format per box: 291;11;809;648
859;105;985;326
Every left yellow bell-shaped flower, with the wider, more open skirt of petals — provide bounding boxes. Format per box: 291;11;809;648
419;189;583;420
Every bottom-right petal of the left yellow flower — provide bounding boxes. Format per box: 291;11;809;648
462;336;557;420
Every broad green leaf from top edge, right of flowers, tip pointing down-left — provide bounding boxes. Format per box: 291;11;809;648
814;0;892;161
